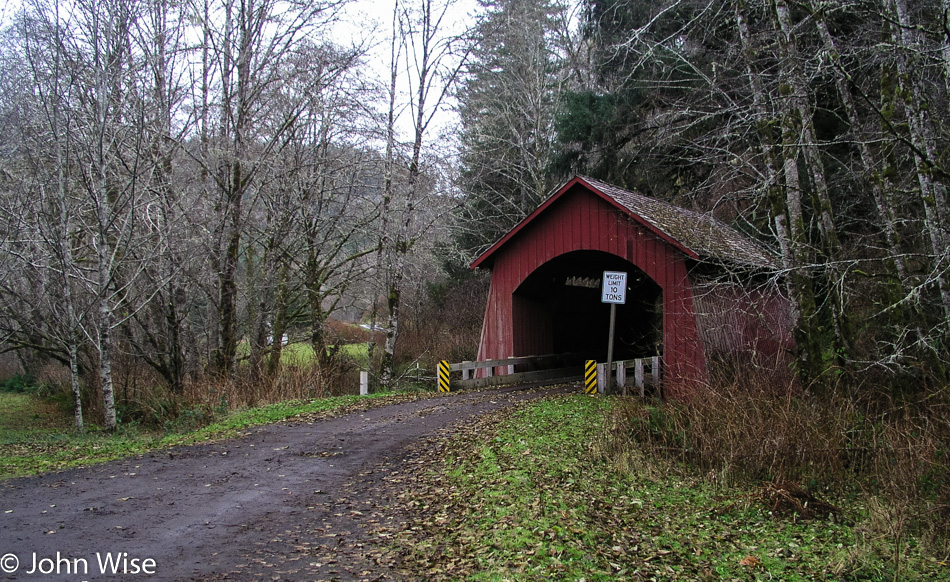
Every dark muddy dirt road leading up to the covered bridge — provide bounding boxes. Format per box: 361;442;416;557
0;389;568;580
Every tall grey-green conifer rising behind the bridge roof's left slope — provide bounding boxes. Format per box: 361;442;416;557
456;0;564;254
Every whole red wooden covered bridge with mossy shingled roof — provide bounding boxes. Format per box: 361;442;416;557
472;177;793;393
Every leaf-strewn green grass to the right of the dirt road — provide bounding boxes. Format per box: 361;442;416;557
397;395;950;581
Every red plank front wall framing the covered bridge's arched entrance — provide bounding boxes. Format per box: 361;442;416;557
478;184;706;392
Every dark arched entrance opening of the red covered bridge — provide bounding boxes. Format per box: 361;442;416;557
512;251;663;362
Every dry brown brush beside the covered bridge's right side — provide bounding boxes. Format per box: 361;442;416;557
608;369;950;547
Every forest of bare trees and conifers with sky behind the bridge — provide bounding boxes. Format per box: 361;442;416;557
0;0;950;428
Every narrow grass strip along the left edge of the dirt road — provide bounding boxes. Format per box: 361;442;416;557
0;393;423;479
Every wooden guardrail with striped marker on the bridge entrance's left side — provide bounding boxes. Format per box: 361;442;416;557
438;354;581;392
